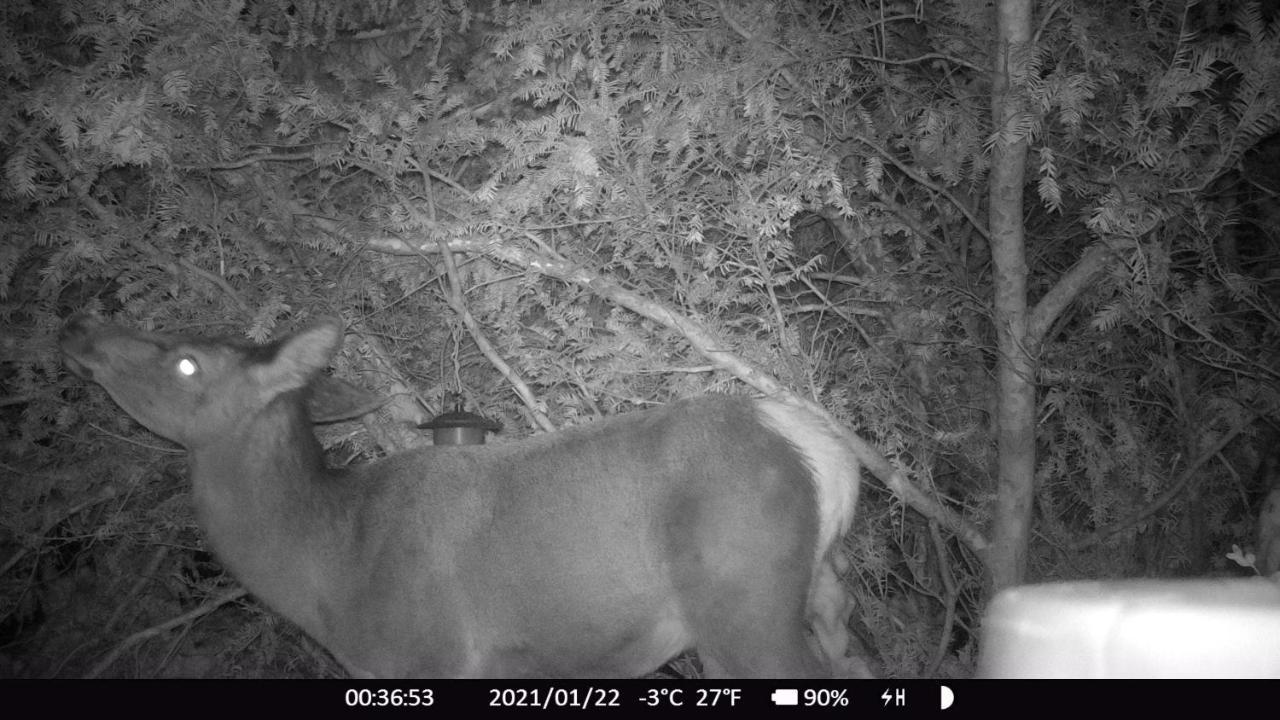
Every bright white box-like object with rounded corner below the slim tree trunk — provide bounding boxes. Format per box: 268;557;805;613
978;575;1280;678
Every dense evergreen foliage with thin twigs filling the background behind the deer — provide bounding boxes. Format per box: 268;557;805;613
0;0;1280;675
